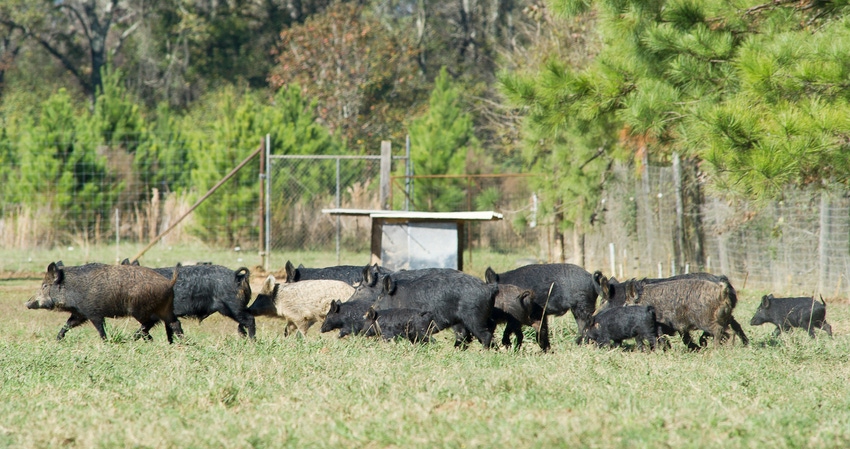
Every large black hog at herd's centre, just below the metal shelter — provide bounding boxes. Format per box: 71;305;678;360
375;268;498;348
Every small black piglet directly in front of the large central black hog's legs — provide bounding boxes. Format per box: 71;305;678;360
366;307;436;343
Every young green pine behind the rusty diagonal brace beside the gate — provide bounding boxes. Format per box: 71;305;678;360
184;86;343;246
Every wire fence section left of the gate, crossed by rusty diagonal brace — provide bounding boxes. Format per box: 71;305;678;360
0;139;262;277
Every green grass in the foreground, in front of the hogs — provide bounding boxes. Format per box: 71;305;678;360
0;281;850;448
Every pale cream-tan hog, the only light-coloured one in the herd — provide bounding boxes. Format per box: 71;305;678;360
248;275;354;335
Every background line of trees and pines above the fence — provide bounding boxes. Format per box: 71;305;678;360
0;0;850;265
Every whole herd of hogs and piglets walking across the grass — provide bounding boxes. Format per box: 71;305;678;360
26;260;832;351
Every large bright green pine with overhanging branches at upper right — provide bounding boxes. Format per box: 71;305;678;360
503;0;850;265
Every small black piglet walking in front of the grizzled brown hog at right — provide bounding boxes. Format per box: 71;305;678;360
586;306;658;351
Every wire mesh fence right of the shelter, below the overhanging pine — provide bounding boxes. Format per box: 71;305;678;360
587;163;850;297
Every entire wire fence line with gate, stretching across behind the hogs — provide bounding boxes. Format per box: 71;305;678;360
0;134;850;297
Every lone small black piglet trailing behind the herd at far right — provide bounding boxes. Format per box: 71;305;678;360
750;295;832;338
